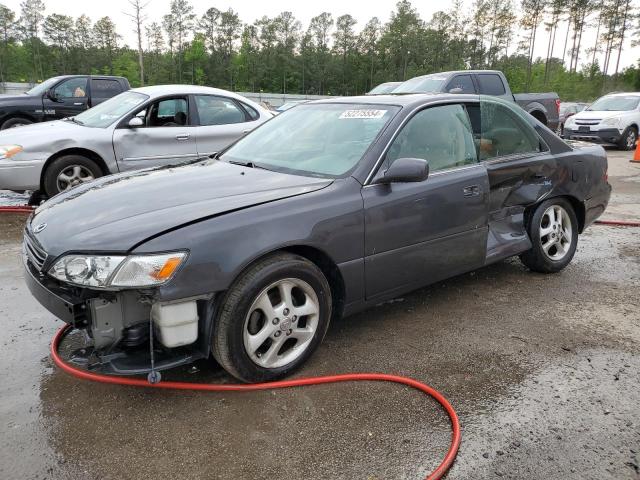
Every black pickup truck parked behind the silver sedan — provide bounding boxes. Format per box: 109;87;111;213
0;75;131;130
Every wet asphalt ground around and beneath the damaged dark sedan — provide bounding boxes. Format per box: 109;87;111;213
0;151;640;480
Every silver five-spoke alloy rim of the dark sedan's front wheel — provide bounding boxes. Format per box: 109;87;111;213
242;278;320;369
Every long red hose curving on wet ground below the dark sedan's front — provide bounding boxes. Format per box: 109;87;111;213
51;325;461;480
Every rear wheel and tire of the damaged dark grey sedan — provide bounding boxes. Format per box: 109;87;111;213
520;198;578;273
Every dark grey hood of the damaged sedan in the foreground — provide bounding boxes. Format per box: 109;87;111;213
30;160;332;256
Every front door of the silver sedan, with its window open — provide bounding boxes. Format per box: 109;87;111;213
113;95;198;171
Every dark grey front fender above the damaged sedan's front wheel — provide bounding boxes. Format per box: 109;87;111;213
133;178;364;300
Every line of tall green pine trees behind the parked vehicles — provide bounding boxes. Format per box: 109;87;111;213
0;0;640;100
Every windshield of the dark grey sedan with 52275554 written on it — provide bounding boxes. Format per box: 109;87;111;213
220;103;399;178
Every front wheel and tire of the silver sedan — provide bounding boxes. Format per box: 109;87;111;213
43;155;102;198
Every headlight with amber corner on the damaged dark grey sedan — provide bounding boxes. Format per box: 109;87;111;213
49;252;187;288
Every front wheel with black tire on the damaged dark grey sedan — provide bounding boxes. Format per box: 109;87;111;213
212;253;332;382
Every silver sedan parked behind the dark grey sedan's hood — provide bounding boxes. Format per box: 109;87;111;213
0;85;273;197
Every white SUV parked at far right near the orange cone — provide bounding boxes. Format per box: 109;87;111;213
563;93;640;150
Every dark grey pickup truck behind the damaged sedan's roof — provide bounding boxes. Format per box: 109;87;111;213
391;70;560;131
